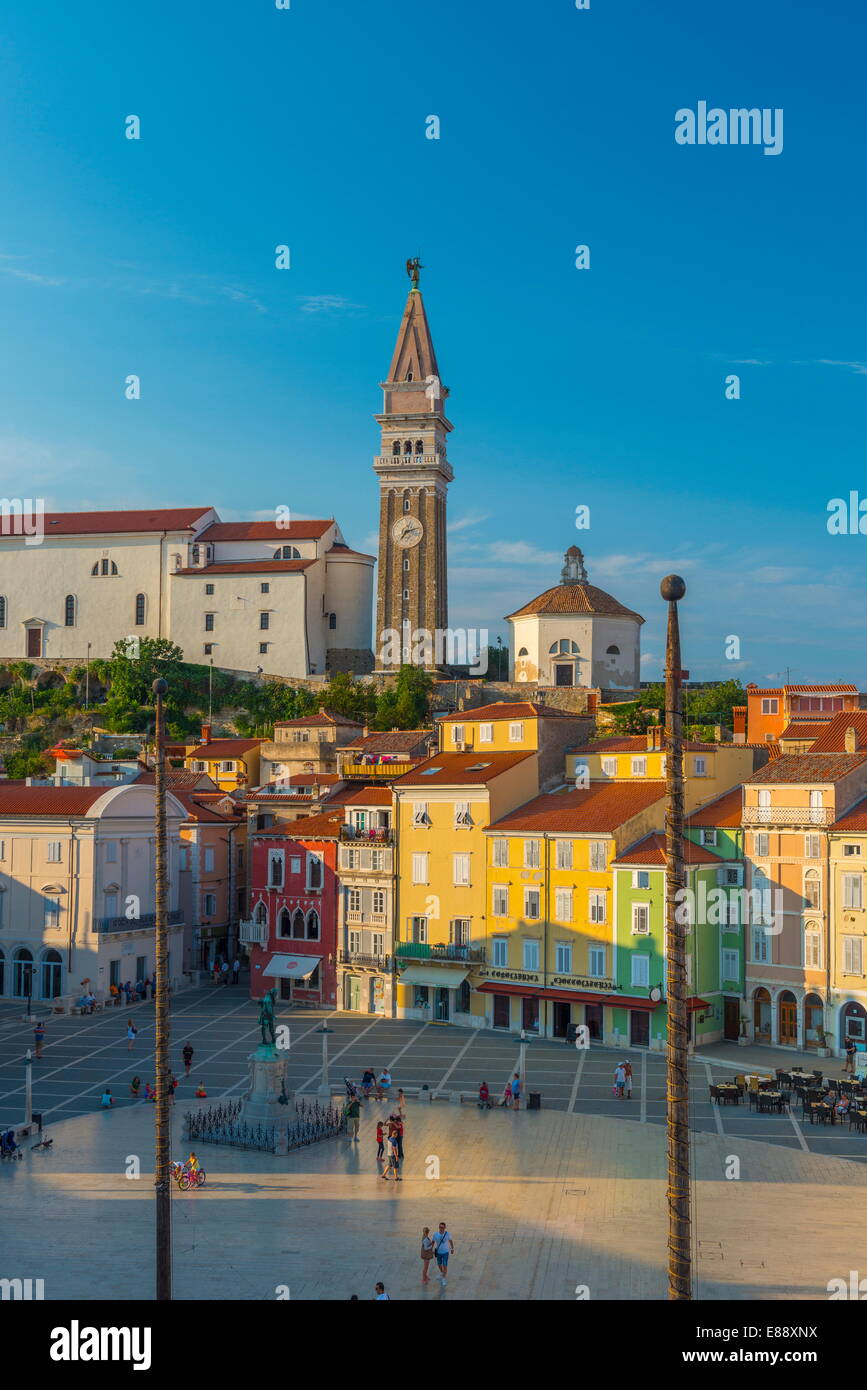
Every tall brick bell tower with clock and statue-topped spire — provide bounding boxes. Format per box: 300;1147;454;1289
374;259;454;670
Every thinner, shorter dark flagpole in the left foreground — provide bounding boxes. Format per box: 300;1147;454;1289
153;680;172;1301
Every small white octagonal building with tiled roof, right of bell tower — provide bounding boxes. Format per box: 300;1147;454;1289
506;545;645;689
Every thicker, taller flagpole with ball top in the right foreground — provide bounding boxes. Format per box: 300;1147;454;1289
660;574;692;1300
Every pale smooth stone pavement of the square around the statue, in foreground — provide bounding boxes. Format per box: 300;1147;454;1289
0;1102;867;1301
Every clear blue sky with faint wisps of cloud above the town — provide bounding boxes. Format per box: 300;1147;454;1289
0;0;867;687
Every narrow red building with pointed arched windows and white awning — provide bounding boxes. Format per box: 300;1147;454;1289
249;810;343;1009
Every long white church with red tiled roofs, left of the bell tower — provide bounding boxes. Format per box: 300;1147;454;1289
0;507;375;676
